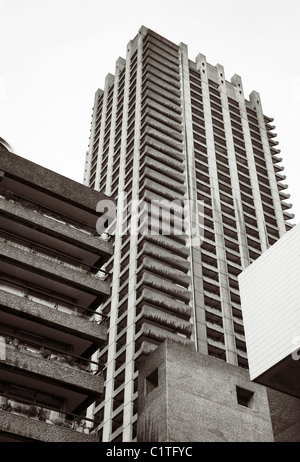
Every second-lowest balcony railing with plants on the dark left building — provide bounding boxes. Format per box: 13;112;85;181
0;331;104;375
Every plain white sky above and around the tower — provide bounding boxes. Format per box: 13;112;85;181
0;0;300;223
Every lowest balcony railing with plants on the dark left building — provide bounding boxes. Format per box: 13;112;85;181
0;394;99;435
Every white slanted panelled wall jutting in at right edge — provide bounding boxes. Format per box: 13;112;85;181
239;224;300;380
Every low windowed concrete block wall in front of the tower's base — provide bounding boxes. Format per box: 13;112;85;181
138;342;274;442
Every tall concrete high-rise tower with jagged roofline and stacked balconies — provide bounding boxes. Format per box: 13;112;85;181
84;27;293;441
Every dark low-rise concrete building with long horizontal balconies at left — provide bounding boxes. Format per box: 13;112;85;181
0;143;112;442
